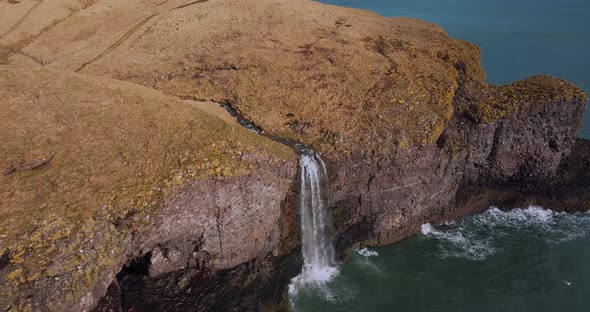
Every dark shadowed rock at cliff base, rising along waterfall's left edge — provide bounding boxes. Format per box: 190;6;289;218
108;171;303;312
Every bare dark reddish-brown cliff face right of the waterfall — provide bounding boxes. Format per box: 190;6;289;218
331;77;590;251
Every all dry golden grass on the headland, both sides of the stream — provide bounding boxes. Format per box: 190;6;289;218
0;0;585;310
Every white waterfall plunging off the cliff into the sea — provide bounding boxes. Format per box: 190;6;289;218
289;150;338;295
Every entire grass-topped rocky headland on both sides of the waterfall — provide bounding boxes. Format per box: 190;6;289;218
0;0;590;311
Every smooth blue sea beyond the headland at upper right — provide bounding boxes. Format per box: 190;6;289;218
321;0;590;139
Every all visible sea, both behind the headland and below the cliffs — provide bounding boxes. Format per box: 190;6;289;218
291;0;590;312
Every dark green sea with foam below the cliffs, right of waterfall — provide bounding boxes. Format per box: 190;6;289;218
291;207;590;312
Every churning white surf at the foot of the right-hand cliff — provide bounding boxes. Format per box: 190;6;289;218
421;206;590;260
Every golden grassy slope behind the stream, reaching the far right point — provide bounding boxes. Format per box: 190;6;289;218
0;0;583;158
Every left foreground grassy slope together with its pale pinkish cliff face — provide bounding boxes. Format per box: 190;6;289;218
0;66;296;311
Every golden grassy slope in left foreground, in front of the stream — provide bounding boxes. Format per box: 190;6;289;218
0;66;295;310
